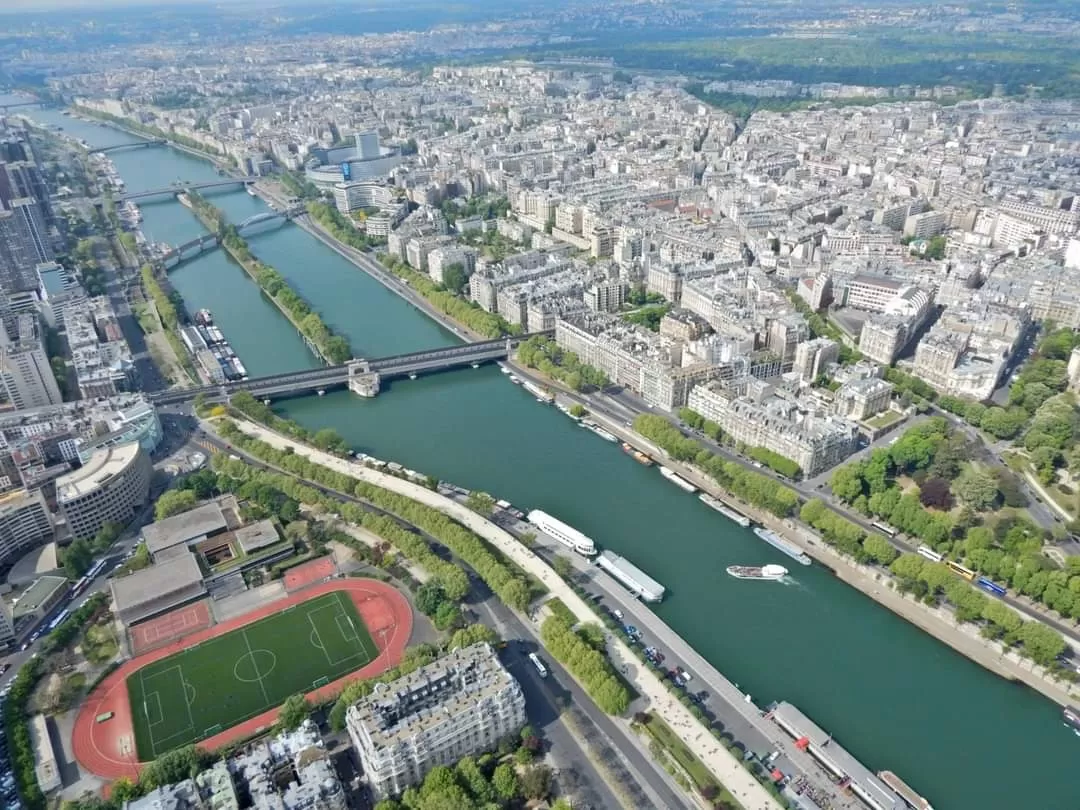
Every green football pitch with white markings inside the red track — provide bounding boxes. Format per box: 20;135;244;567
127;592;378;761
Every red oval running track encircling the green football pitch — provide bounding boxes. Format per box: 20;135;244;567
71;579;413;780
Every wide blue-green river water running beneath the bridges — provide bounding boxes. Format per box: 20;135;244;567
36;111;1080;810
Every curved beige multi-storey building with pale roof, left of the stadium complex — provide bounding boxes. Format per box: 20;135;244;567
56;442;153;538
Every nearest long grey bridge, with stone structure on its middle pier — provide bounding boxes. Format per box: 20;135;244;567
149;332;551;405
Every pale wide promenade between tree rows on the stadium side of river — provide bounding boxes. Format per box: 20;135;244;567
212;420;781;810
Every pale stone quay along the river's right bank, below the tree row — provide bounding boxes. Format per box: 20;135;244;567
509;362;1080;706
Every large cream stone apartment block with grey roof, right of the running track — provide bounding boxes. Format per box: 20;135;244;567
346;644;525;799
